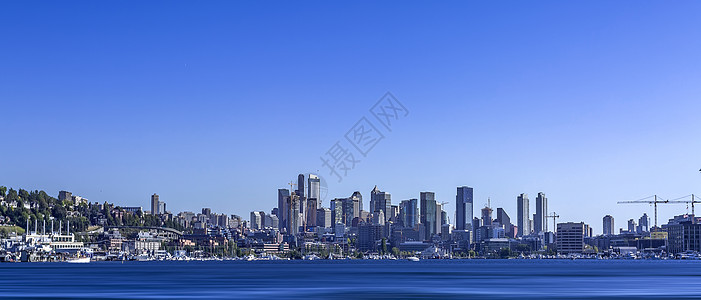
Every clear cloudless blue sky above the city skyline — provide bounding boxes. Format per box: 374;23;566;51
0;1;701;232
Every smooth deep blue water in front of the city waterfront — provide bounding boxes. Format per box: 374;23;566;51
0;260;701;299
